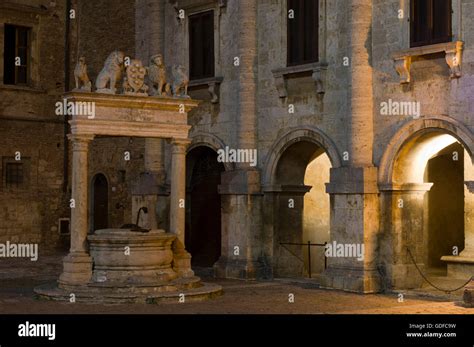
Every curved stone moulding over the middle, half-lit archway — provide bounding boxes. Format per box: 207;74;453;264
263;127;342;186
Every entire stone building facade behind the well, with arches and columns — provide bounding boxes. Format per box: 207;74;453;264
0;0;474;293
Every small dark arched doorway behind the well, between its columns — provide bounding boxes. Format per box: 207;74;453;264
90;174;109;232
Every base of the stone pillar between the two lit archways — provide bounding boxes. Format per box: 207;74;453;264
321;268;382;294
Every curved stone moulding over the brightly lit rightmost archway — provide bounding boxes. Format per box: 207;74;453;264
378;116;474;185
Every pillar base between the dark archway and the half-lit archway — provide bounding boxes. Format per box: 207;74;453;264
214;257;273;280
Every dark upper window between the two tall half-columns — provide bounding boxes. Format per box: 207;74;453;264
287;0;319;66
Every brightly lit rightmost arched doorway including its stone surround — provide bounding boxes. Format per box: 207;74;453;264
379;119;474;289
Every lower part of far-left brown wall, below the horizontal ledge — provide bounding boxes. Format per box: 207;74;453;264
0;120;69;254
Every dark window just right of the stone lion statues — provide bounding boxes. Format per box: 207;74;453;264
189;11;214;80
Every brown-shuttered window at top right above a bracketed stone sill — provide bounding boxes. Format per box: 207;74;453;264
410;0;451;47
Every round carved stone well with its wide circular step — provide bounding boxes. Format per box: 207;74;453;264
35;229;222;303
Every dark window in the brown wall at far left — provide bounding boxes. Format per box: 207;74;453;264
3;24;30;84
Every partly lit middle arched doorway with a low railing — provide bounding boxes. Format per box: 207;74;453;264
273;139;331;277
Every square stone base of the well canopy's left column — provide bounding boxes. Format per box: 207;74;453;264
58;253;92;289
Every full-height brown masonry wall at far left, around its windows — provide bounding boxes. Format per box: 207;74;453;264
0;0;69;255
